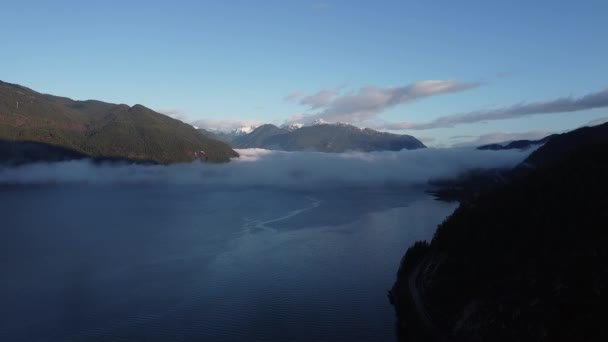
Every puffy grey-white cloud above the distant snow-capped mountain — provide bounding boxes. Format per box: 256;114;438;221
287;80;480;124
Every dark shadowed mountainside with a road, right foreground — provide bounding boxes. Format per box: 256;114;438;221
390;124;608;341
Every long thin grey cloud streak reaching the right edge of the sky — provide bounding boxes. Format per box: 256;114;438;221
382;89;608;130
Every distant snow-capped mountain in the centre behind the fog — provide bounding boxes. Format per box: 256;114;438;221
232;123;425;152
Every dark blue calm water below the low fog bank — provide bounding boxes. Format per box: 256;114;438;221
0;184;455;341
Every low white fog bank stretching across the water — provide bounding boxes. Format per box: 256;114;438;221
0;148;531;189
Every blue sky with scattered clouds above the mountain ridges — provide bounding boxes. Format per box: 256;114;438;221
0;0;608;147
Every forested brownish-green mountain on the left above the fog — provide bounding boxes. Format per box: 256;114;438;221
0;81;238;163
